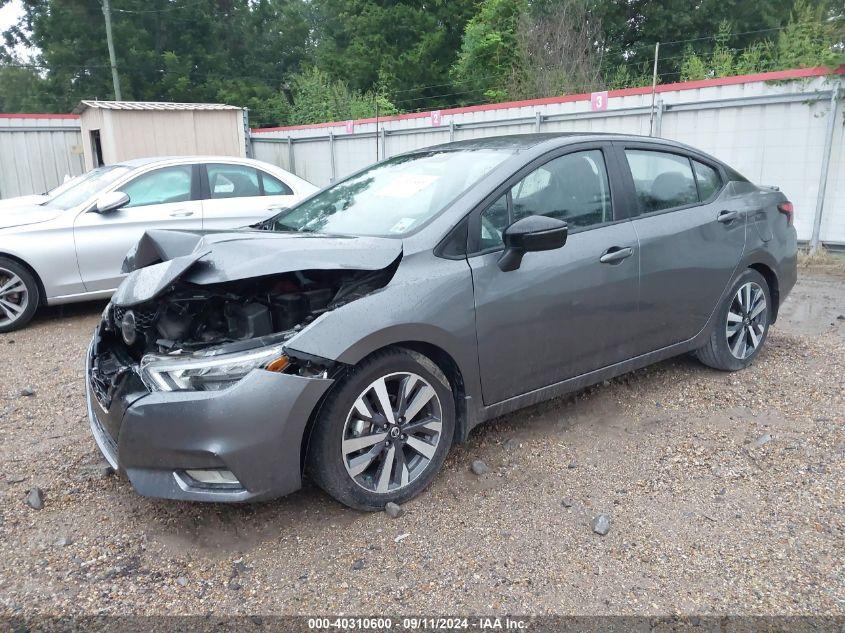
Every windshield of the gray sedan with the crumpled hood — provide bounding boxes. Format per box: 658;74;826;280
266;149;512;237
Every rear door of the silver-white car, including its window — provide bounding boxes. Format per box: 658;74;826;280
202;163;298;229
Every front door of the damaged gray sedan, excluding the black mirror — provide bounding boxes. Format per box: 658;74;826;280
468;146;639;405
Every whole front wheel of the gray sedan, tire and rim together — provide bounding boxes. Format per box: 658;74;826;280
306;348;455;511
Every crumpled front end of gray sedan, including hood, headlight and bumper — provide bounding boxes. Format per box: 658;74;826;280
87;232;401;501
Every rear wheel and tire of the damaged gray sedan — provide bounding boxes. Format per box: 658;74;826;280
695;268;772;371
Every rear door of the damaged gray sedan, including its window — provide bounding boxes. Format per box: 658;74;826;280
615;142;746;354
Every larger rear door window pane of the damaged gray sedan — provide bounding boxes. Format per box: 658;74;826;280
625;149;698;213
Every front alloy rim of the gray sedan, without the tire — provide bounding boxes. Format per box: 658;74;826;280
342;372;443;494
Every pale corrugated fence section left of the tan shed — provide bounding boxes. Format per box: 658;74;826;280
0;114;84;199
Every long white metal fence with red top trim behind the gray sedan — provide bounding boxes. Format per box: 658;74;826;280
251;68;845;244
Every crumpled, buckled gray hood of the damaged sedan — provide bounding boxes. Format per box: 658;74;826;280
112;229;402;306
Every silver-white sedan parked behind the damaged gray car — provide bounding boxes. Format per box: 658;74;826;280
0;156;317;332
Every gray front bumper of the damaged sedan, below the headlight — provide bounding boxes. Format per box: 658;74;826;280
85;332;333;502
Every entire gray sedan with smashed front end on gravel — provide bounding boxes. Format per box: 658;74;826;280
82;135;797;510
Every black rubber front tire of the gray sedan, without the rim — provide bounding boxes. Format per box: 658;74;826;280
307;348;455;510
